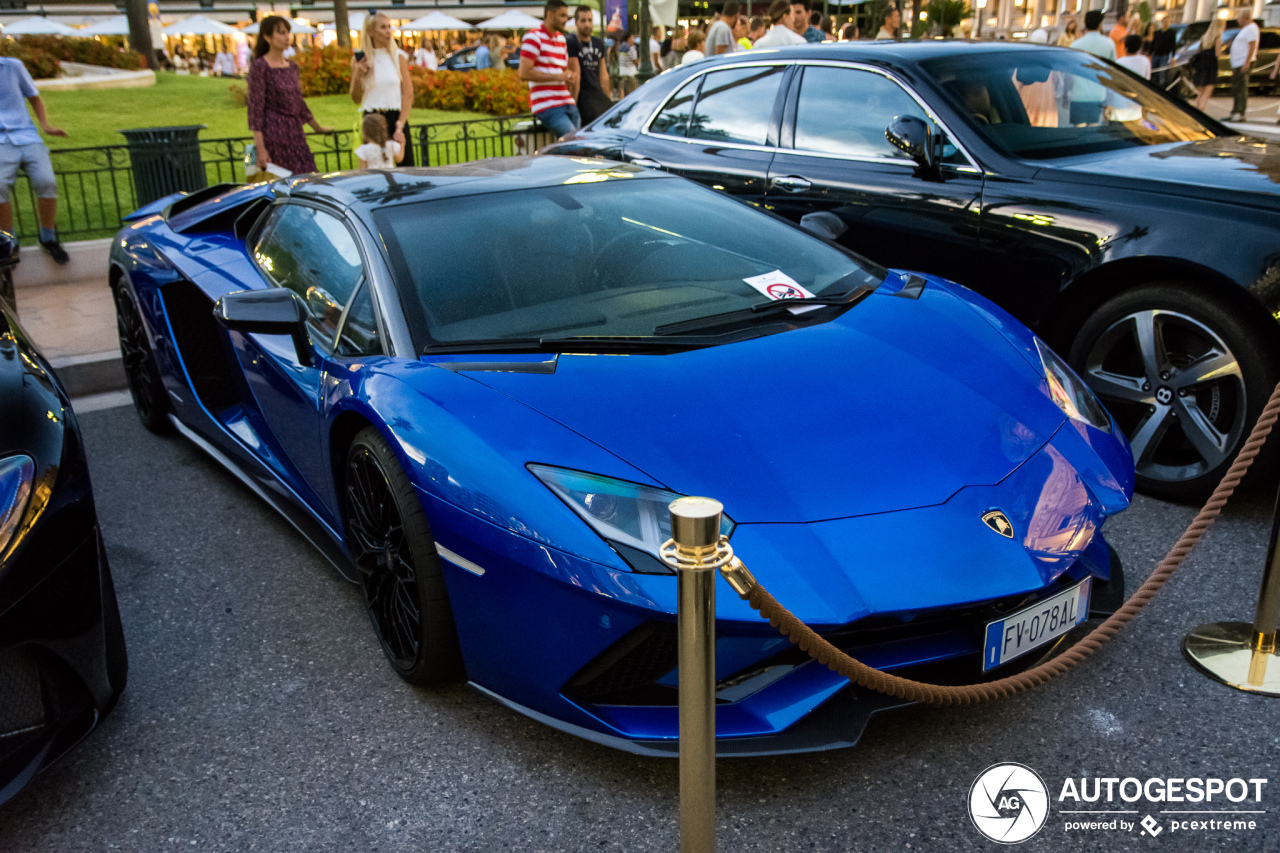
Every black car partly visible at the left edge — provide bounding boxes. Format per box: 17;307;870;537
0;247;128;803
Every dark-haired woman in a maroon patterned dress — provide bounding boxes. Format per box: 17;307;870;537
248;15;333;173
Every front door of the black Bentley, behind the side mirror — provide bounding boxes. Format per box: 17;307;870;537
765;63;983;283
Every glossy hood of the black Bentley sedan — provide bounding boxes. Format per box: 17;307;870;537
1059;136;1280;204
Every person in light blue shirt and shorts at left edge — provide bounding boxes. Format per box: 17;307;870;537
0;56;70;264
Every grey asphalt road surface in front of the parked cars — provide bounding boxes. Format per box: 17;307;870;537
0;399;1280;853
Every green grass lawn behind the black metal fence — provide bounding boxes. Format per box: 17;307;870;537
13;73;515;245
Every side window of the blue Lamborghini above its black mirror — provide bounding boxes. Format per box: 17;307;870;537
253;204;364;348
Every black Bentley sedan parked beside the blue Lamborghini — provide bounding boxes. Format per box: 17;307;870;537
544;41;1280;500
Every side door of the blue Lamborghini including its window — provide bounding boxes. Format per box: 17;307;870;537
240;201;365;507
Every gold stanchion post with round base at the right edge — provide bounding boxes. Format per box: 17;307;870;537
1183;479;1280;695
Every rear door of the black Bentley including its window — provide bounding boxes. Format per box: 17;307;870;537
625;63;790;201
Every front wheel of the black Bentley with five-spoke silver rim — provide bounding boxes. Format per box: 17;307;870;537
1070;284;1276;501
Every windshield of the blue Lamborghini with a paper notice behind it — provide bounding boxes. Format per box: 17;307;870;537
375;172;884;346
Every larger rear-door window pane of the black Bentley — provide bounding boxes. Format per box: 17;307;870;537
689;65;785;145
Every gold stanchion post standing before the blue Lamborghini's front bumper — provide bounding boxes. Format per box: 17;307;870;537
663;497;732;853
